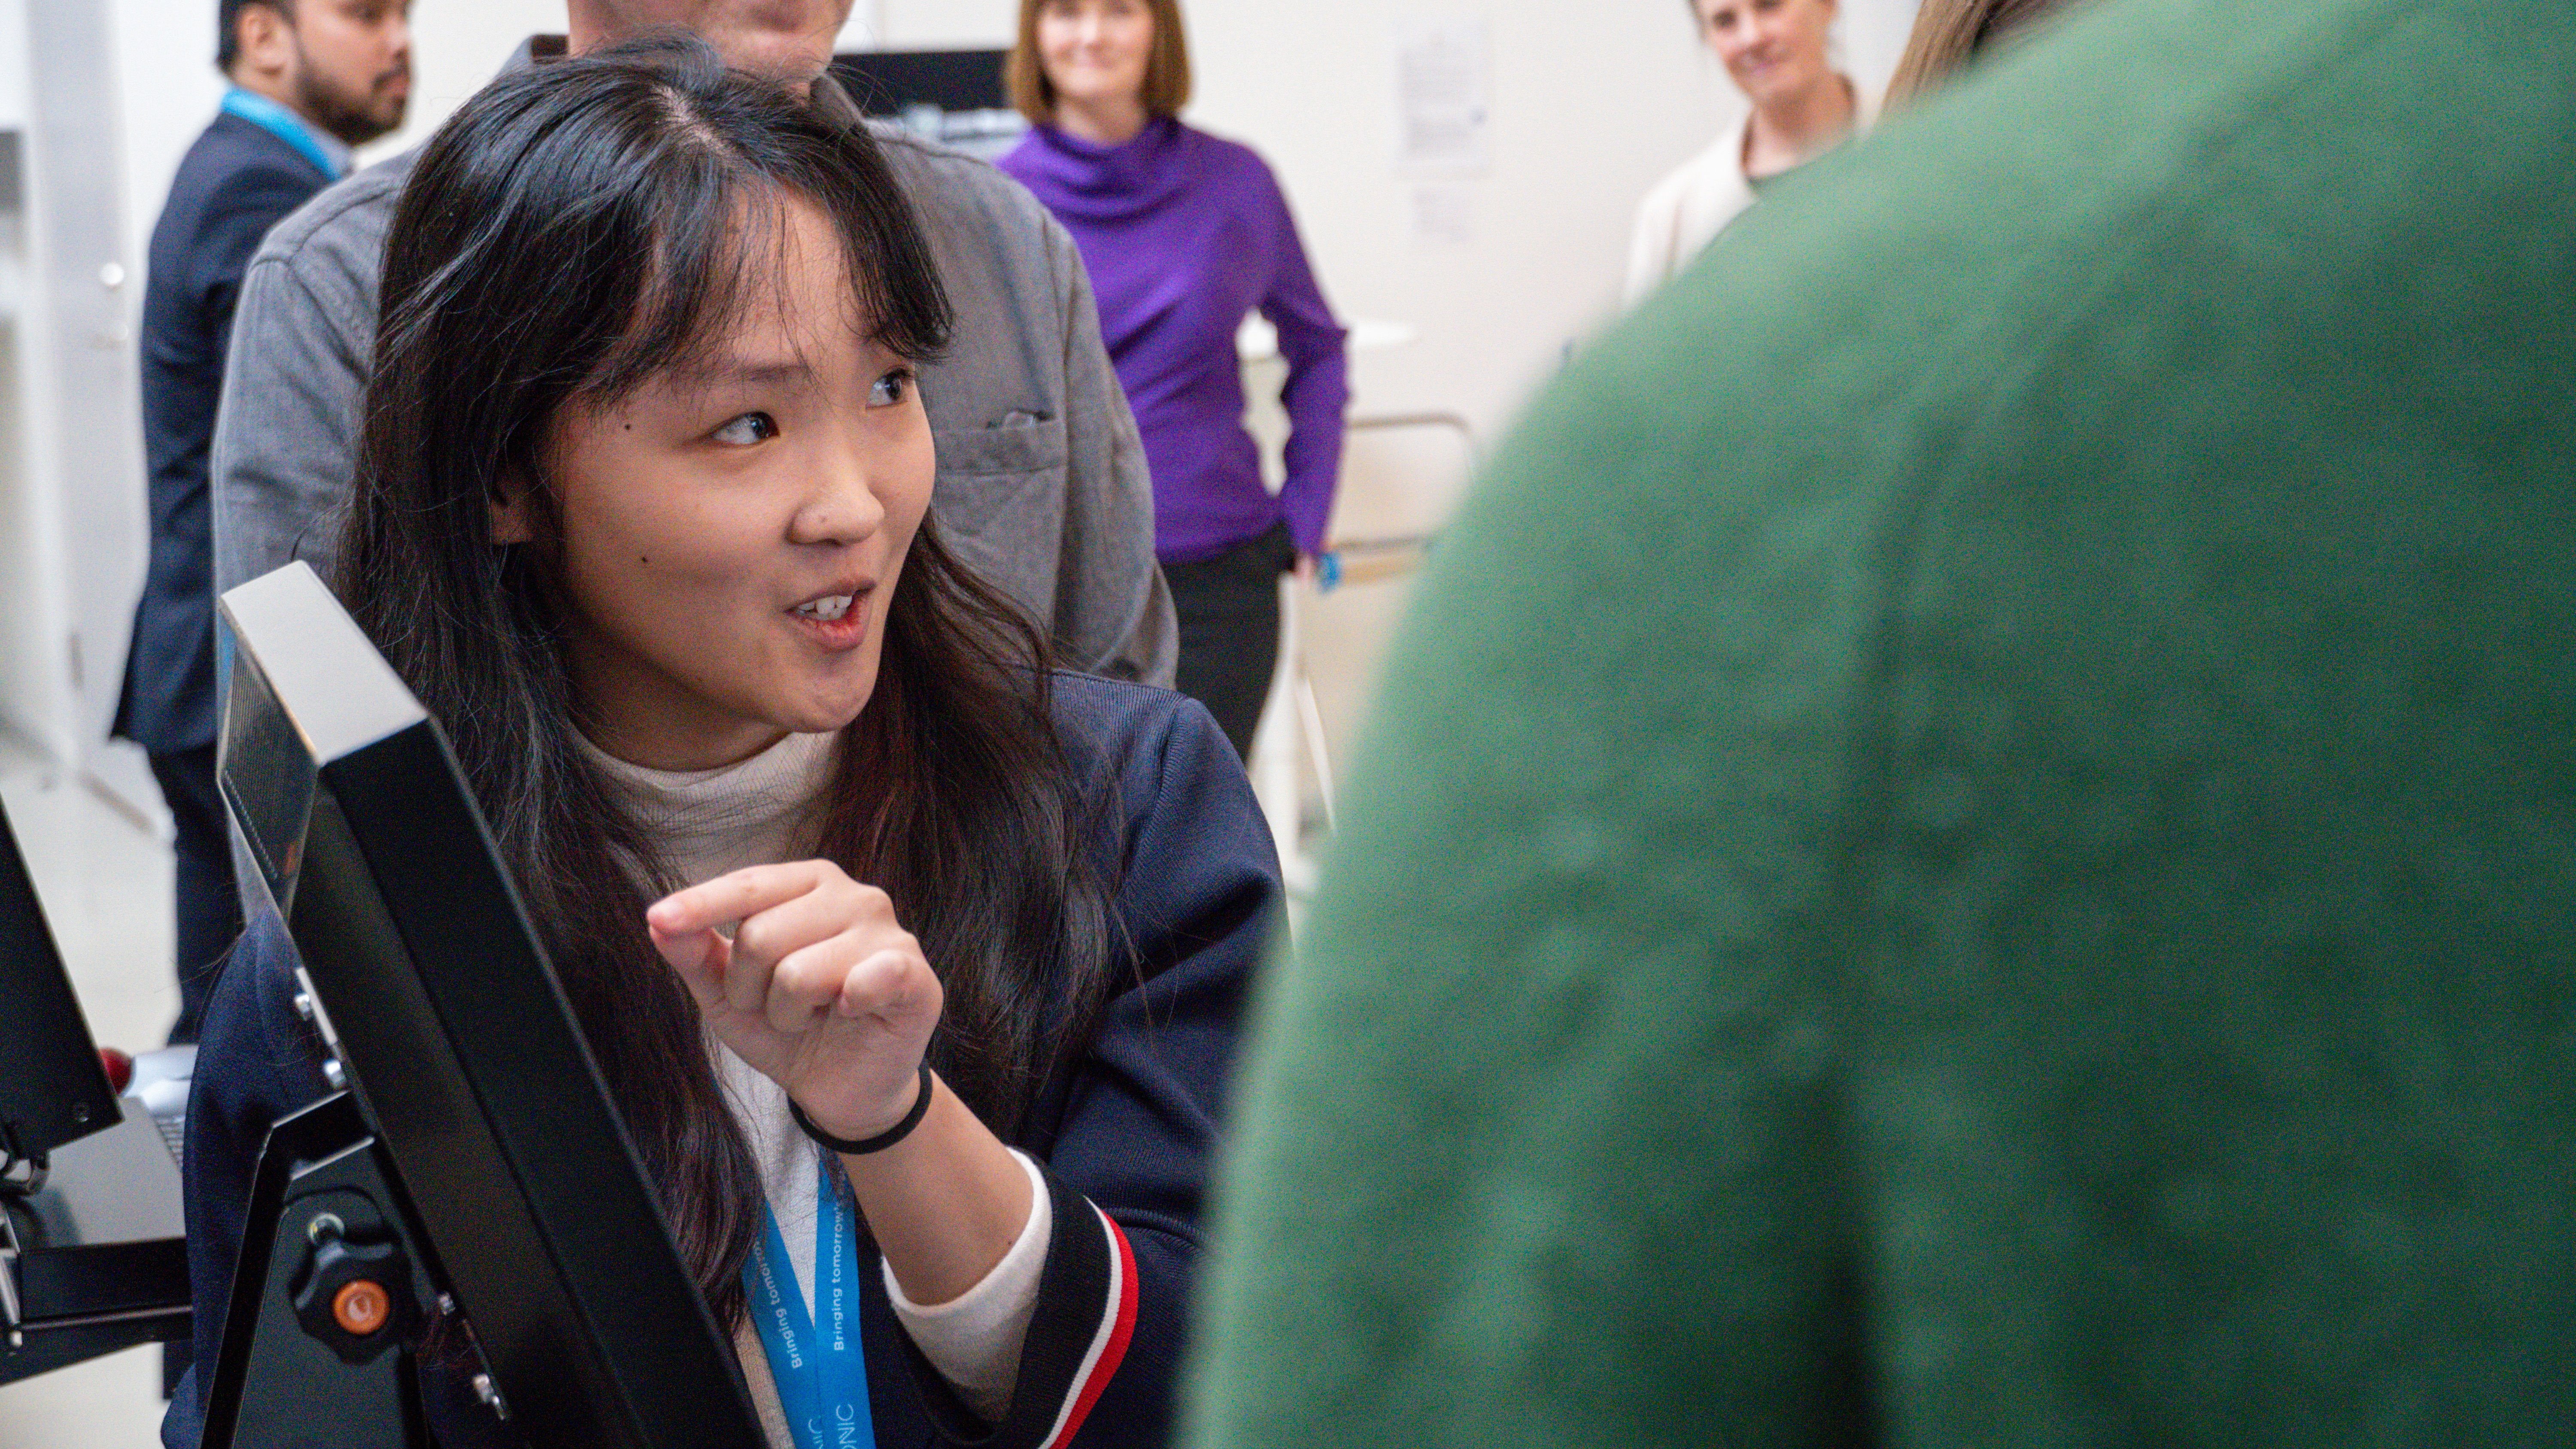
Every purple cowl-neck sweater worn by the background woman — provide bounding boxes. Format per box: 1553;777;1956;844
1002;118;1350;564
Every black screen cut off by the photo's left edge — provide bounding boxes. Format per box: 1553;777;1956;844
0;787;124;1181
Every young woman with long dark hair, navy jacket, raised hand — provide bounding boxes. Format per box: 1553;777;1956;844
180;41;1278;1446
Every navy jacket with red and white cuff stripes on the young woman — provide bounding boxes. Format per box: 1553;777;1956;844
162;674;1280;1449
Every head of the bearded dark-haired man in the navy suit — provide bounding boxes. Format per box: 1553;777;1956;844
214;0;412;147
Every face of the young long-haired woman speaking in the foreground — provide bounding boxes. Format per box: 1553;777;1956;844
492;198;933;770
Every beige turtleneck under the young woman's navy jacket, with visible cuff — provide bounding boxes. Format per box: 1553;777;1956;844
585;734;1054;1449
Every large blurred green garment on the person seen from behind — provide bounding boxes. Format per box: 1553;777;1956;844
1193;0;2576;1449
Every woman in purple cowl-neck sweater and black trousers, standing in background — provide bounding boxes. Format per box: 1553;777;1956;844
1002;0;1350;754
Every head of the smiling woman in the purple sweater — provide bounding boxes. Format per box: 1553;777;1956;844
1005;0;1190;126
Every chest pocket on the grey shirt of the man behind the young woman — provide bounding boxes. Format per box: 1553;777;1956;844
930;417;1066;620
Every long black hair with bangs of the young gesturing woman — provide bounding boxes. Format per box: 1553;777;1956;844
337;36;1113;1320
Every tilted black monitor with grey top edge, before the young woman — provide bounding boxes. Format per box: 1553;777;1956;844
216;564;760;1449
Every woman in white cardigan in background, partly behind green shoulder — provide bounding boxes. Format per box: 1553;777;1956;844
1625;0;1875;306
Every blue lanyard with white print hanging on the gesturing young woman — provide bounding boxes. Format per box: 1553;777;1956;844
742;1153;876;1449
